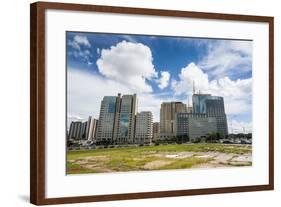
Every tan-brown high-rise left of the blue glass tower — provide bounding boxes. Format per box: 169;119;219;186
160;102;187;139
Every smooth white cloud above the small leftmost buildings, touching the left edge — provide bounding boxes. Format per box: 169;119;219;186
67;69;129;123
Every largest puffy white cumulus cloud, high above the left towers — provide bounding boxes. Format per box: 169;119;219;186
96;41;157;92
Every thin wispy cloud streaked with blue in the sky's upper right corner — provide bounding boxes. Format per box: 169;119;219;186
198;40;252;78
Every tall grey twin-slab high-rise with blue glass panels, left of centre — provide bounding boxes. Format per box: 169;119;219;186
97;94;137;144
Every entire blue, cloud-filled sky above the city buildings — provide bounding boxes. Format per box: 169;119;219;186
66;32;253;133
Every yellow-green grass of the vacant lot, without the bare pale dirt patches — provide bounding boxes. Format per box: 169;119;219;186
67;143;252;174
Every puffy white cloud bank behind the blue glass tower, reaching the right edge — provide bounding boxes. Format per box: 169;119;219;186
172;63;252;115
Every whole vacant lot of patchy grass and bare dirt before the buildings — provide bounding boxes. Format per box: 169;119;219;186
67;144;252;174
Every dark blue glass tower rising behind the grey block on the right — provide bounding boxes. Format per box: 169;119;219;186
192;94;228;137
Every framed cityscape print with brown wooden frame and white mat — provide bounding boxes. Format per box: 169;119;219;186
30;2;274;205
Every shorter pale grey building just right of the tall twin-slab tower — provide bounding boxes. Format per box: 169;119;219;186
135;111;153;144
